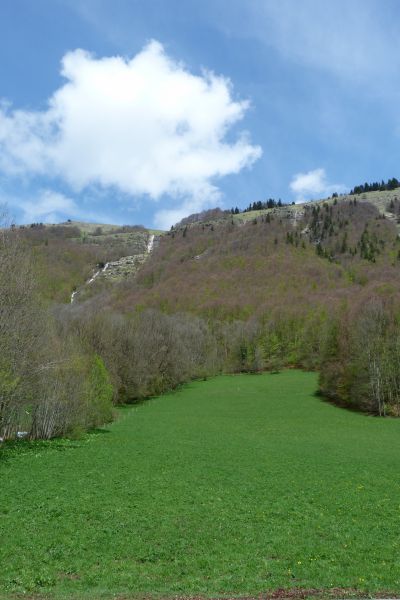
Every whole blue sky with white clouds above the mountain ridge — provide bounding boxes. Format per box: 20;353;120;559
0;0;400;229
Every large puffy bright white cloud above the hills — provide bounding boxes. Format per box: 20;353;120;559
0;41;261;227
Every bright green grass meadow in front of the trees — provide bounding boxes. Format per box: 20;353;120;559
0;371;400;598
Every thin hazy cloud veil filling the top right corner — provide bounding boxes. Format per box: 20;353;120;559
213;0;400;85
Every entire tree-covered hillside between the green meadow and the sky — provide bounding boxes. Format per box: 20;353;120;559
0;189;400;438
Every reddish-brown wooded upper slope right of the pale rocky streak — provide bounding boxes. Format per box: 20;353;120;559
105;194;400;319
